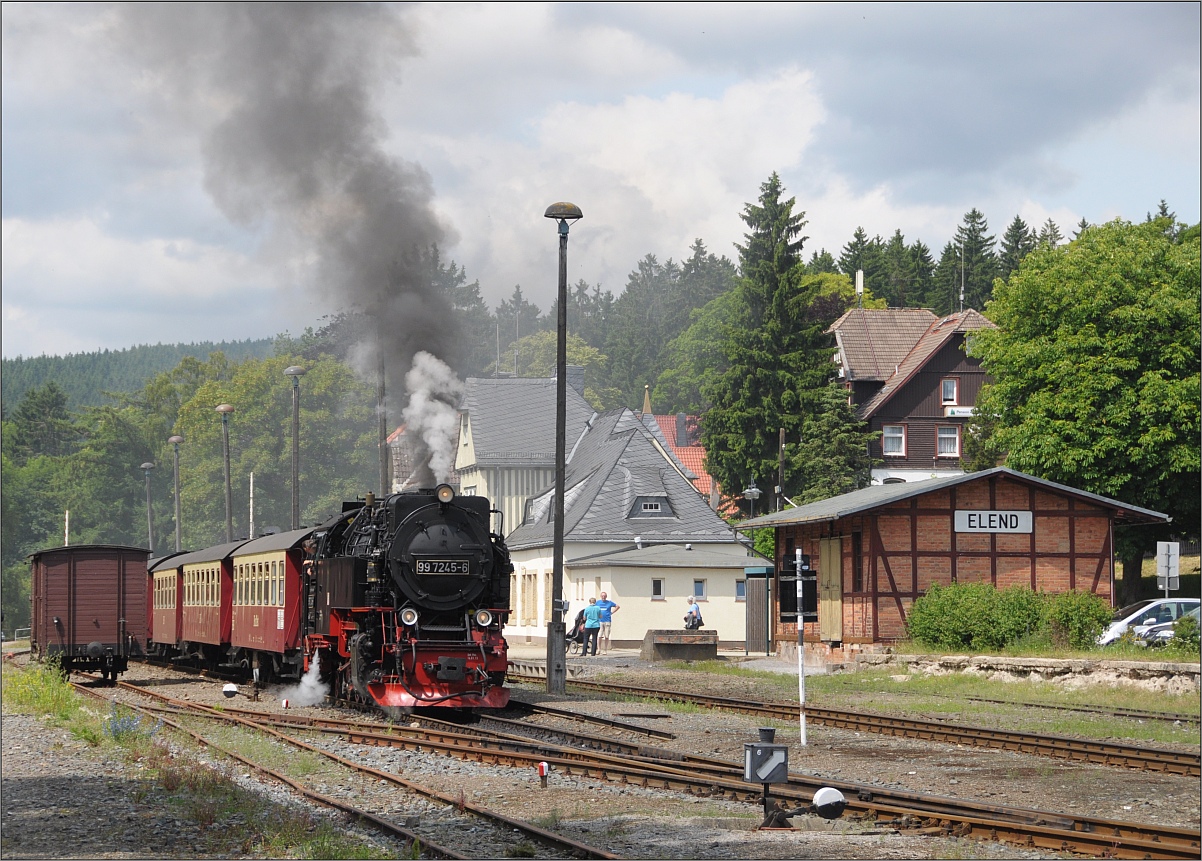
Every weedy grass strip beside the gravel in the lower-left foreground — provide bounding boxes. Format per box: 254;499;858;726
2;664;401;859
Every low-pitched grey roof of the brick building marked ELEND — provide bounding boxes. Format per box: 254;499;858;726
739;467;1170;530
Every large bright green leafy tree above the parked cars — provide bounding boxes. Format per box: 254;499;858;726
970;219;1202;599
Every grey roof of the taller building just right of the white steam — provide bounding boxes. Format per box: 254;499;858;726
459;378;593;467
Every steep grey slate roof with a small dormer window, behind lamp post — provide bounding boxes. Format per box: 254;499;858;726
506;409;736;550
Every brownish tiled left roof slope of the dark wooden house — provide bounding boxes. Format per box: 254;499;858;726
827;308;939;382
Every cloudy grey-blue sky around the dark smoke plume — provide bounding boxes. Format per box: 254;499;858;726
2;2;1200;357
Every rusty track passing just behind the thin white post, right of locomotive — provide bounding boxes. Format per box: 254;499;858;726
511;675;1202;777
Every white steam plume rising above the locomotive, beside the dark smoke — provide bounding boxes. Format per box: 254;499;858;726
404;350;463;482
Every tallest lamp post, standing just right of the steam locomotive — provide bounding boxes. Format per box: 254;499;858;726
543;202;584;694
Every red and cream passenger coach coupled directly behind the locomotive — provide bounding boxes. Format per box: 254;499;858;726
230;528;314;682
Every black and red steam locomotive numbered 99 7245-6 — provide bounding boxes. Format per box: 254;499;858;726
305;485;513;717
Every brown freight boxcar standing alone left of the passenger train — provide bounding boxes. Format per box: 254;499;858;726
29;545;150;681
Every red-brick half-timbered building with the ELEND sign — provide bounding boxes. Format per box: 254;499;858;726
739;467;1170;663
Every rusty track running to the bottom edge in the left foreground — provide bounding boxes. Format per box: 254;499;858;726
76;682;617;859
